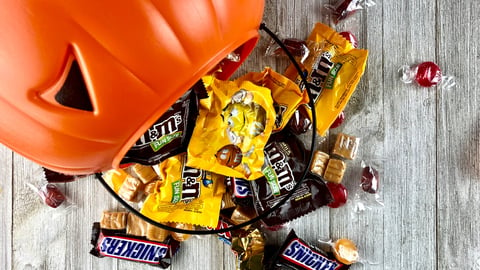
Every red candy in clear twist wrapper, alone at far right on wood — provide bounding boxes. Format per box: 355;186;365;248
399;61;455;89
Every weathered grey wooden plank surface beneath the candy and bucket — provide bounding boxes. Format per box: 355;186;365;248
0;0;480;270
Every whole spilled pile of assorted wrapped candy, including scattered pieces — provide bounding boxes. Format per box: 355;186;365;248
32;0;454;269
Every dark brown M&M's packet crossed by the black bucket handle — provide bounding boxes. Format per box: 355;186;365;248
251;132;332;226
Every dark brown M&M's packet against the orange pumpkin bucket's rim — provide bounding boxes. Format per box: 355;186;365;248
121;81;207;165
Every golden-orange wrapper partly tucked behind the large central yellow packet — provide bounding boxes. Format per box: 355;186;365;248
237;67;309;132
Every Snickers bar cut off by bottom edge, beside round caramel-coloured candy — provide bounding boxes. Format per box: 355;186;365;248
265;230;350;270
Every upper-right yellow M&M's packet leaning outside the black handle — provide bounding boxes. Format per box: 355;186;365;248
285;23;368;135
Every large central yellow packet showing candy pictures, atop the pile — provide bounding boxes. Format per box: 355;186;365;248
187;76;275;179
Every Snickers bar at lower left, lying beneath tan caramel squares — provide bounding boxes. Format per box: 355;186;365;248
90;222;180;269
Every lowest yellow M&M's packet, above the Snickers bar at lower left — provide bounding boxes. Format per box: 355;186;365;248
140;153;225;227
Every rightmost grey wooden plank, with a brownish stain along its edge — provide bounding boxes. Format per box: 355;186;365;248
436;1;480;269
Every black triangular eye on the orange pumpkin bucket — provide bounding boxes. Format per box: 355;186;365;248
55;61;93;112
